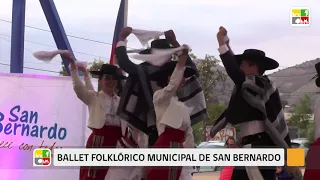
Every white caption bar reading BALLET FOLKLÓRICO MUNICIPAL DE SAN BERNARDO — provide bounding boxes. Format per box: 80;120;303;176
53;148;285;166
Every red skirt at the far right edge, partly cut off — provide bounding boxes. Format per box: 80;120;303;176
303;138;320;180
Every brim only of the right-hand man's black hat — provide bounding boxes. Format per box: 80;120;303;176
235;54;279;70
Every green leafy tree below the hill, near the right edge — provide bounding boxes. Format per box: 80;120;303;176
288;95;312;137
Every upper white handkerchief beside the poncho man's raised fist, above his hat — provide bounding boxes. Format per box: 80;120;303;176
132;29;164;46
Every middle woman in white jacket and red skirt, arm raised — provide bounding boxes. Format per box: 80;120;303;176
146;45;196;180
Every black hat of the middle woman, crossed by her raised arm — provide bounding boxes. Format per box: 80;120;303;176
149;61;197;81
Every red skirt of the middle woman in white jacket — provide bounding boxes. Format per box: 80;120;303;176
146;127;185;180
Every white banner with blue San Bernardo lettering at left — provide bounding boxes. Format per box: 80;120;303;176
0;74;96;180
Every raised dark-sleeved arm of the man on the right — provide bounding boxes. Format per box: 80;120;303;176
217;27;245;84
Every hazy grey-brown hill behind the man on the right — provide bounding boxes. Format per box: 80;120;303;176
205;58;320;110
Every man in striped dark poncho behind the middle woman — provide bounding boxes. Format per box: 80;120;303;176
116;27;207;147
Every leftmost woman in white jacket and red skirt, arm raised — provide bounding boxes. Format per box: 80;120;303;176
63;53;124;180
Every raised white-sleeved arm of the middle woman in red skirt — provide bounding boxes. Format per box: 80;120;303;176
153;46;188;104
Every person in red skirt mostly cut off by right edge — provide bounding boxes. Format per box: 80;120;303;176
303;63;320;180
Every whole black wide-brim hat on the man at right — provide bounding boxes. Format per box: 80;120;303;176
235;49;279;70
